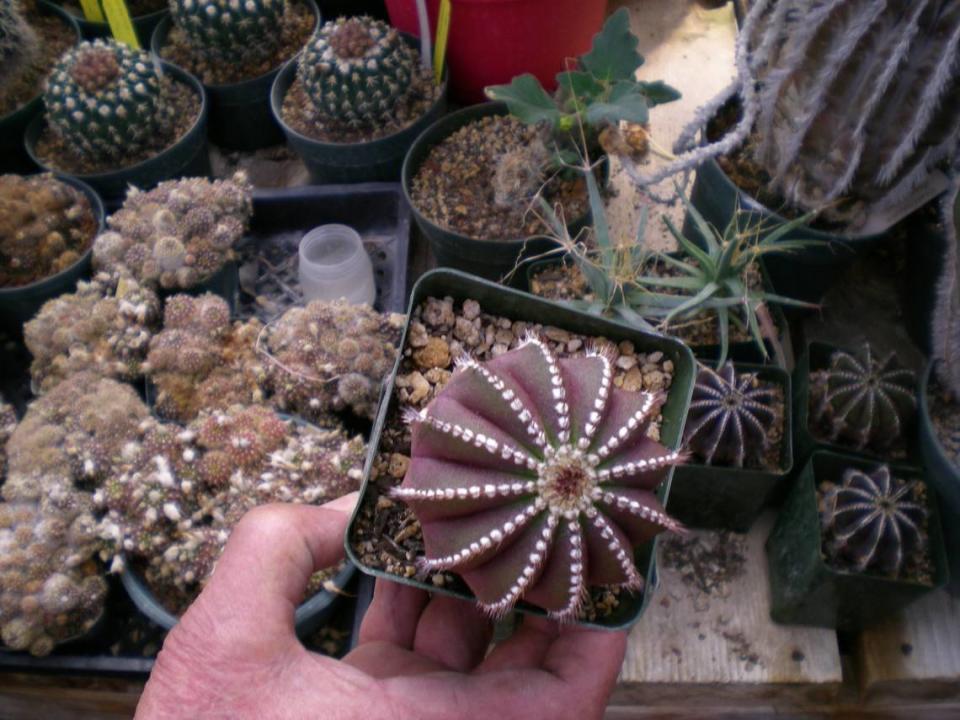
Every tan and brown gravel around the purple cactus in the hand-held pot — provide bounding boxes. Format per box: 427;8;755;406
351;298;674;621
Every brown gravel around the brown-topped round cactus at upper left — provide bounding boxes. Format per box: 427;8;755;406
36;77;200;174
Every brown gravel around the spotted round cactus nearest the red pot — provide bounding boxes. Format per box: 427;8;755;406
281;48;443;143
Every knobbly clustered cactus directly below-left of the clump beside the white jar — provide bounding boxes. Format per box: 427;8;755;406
23;274;160;391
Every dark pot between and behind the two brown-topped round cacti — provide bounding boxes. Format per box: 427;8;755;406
150;0;320;151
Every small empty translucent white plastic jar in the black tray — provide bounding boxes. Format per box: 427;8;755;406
299;224;376;305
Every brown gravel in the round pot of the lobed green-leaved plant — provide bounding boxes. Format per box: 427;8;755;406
410;115;588;240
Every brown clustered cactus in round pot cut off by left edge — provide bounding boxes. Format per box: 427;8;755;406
0;173;97;287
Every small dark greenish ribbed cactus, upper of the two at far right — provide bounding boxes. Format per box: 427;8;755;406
810;345;917;454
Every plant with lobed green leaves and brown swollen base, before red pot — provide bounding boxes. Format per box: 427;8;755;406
486;8;680;210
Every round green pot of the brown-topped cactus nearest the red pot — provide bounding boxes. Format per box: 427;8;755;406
270;33;447;185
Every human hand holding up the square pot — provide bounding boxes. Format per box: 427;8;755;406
136;494;626;720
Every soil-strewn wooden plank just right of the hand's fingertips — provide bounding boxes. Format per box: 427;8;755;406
611;513;842;709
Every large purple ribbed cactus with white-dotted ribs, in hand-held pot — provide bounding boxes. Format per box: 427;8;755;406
393;337;680;621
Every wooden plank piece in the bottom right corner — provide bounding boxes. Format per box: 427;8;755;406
856;590;960;702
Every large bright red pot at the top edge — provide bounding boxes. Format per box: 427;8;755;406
386;0;607;103
